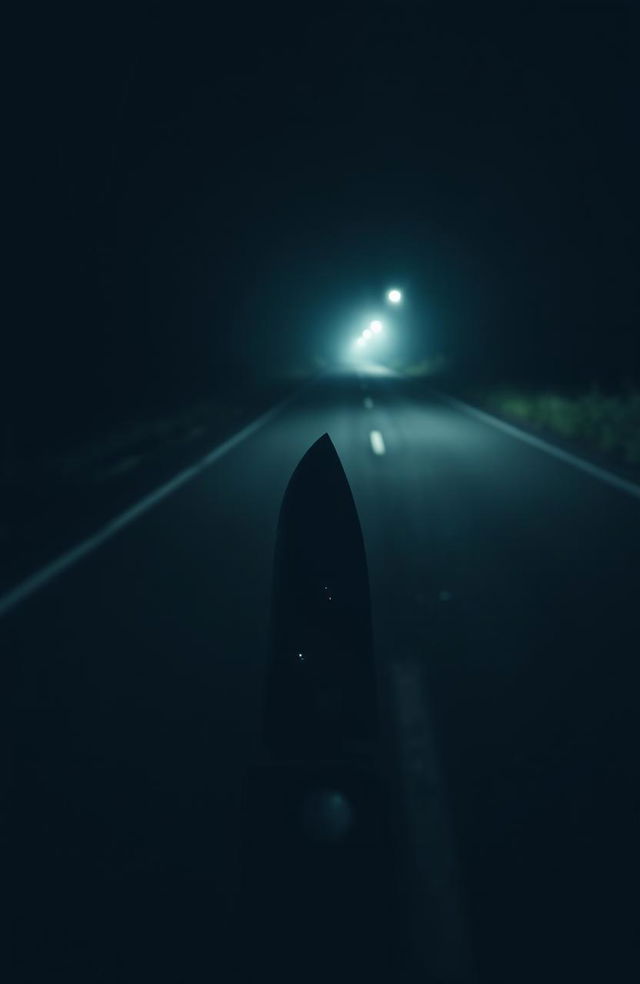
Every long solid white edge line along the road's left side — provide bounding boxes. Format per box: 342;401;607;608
0;390;300;618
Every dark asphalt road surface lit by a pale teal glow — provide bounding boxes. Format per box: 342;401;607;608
5;375;640;982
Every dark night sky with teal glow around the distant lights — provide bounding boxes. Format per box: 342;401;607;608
17;2;640;450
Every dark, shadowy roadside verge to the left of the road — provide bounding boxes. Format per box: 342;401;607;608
0;384;290;589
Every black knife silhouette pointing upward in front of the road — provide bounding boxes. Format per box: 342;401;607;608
240;434;393;981
